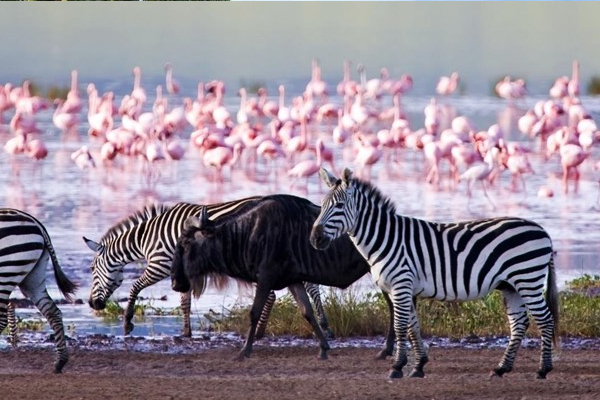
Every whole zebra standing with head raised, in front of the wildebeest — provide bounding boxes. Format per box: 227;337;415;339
311;169;558;378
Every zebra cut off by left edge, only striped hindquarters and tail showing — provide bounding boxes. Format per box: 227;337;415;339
0;208;77;373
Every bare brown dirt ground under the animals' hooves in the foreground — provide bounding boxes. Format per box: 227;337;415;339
0;343;600;400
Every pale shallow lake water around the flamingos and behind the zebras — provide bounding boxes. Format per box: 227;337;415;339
0;78;600;340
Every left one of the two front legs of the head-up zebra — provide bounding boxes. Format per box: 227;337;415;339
388;288;412;379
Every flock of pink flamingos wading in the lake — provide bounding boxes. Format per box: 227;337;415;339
0;60;600;201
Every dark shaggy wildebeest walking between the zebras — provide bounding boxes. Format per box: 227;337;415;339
171;195;393;360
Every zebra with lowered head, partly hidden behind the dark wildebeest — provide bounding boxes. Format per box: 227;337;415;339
83;196;332;338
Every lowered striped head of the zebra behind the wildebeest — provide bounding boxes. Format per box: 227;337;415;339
83;237;124;310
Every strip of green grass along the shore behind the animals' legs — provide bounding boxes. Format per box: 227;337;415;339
211;276;600;339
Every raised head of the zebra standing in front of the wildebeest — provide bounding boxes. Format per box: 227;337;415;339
310;168;356;250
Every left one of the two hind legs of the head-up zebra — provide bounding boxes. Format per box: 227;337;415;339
490;288;529;376
